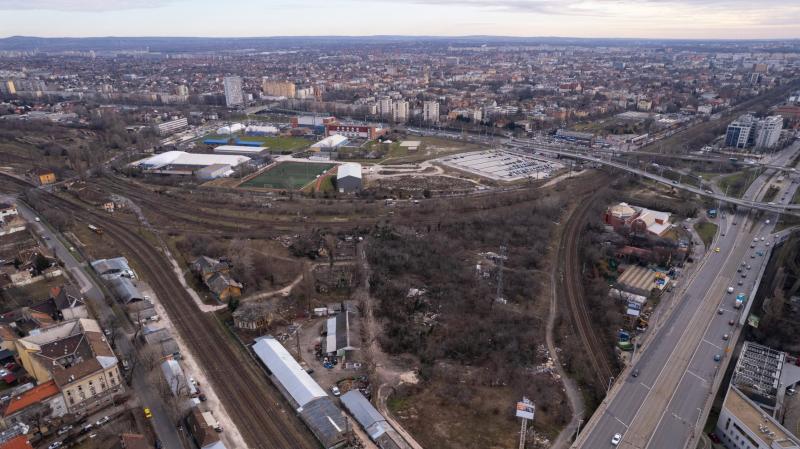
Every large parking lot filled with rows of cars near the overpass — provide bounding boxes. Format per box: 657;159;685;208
439;150;564;182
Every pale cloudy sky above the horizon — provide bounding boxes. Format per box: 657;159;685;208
0;0;800;39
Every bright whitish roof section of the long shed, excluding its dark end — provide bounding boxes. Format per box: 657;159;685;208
253;336;328;407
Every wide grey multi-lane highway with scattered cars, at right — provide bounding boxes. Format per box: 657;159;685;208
573;143;800;449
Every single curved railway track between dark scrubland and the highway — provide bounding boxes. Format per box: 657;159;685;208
558;184;614;389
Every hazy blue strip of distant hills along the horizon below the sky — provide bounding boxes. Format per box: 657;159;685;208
0;36;800;53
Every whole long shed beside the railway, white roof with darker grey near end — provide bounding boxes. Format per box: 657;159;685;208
253;336;347;449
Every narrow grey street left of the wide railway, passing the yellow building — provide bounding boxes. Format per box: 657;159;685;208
17;203;184;449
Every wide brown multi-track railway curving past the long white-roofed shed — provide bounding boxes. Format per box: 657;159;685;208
4;177;319;449
